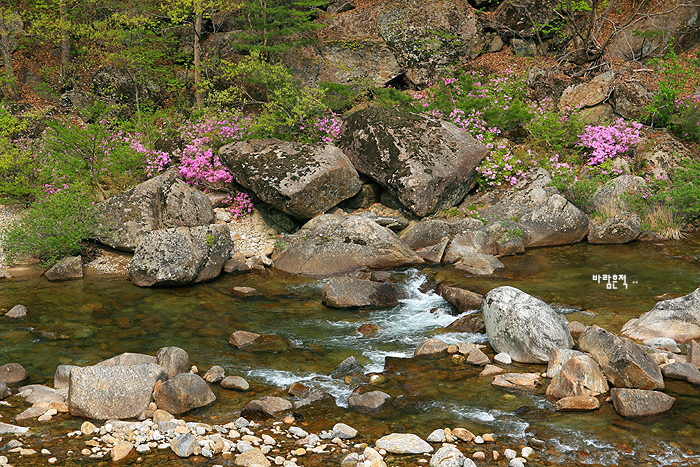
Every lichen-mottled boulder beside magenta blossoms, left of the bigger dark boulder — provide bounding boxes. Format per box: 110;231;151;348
219;139;362;219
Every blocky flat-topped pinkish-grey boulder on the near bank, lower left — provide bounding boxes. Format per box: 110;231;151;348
67;363;168;420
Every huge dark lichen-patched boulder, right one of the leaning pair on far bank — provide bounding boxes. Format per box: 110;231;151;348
338;107;488;217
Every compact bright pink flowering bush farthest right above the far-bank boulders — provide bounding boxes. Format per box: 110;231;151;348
579;118;642;165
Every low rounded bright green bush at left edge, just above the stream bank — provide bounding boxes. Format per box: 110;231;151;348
0;186;98;267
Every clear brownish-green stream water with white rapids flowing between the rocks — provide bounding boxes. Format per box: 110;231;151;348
0;236;700;466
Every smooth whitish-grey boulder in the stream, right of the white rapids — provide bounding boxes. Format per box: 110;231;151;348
482;286;574;363
